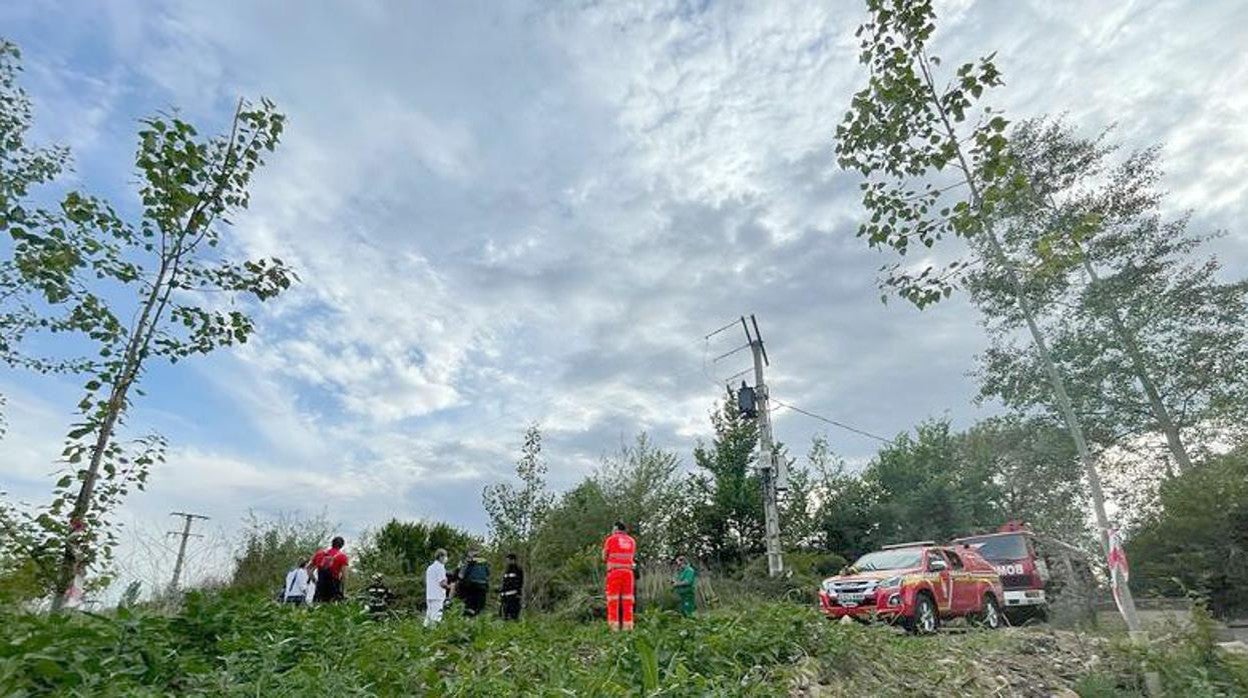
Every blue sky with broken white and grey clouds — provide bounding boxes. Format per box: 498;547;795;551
0;0;1248;584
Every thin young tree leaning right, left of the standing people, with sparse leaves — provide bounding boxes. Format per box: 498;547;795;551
7;93;295;608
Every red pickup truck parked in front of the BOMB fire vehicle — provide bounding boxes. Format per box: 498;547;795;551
819;541;1005;633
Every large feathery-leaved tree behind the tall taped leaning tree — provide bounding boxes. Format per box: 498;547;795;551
970;120;1248;471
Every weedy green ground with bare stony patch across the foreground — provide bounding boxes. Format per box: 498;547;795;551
0;594;1248;697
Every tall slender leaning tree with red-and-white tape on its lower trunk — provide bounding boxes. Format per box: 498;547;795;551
836;0;1138;629
